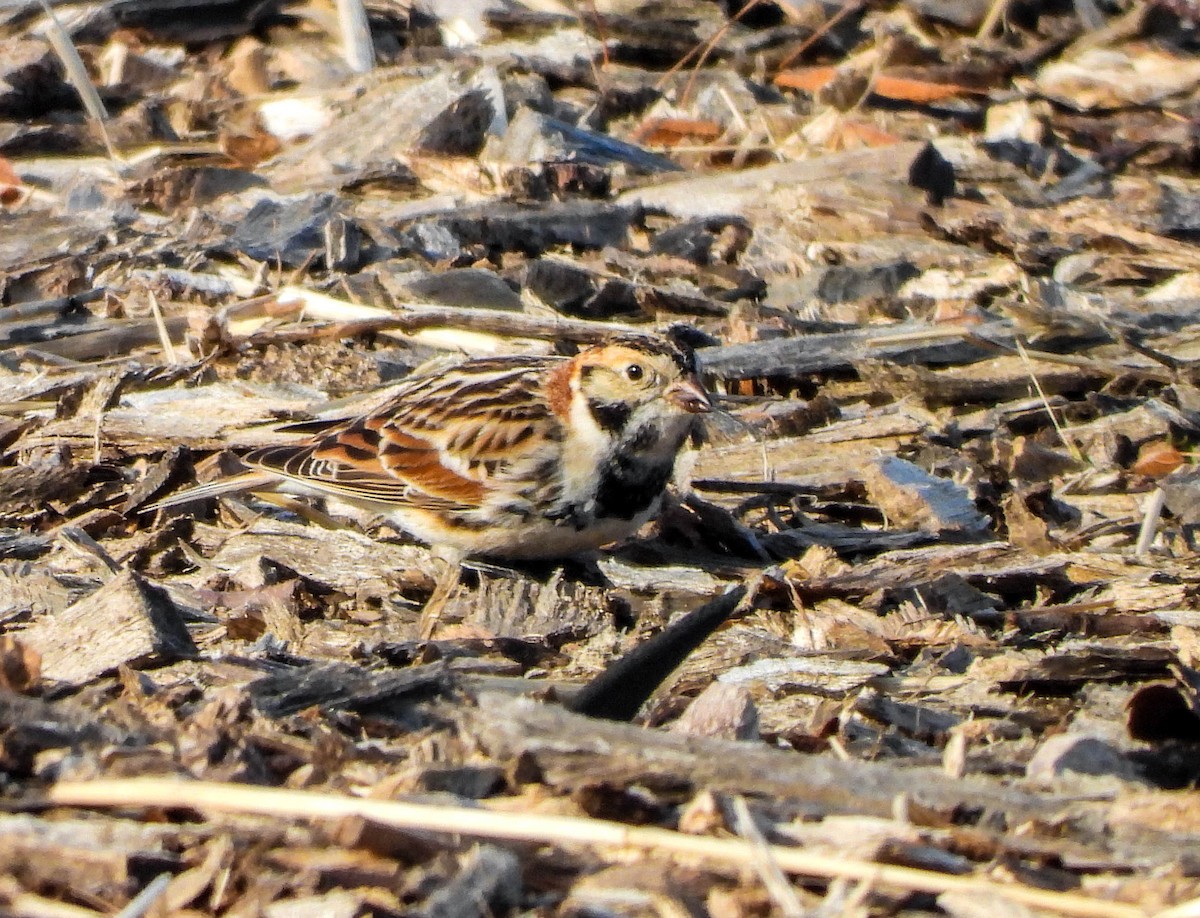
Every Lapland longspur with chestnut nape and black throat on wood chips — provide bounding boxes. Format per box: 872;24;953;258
155;335;712;560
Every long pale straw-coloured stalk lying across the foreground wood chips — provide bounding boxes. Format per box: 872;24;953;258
44;778;1146;918
